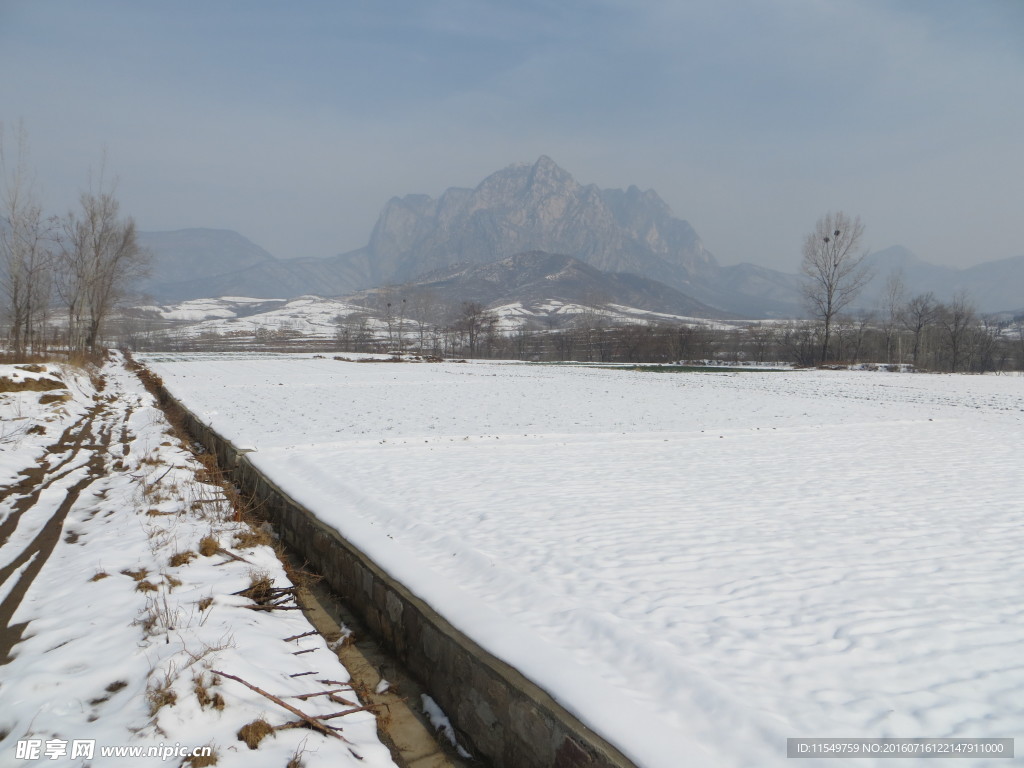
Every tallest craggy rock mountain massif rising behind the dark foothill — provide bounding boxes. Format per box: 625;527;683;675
360;156;716;287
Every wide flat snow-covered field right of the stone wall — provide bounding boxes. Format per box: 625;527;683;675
152;356;1024;768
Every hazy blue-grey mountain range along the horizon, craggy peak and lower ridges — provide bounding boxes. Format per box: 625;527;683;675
142;157;1024;317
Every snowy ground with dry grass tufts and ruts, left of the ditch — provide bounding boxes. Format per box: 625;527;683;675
0;359;393;768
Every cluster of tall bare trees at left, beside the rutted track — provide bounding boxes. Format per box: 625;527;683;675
0;124;148;355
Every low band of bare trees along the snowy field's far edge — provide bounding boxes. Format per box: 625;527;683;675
119;296;1024;373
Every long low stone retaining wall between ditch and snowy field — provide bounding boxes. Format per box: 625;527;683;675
153;389;635;768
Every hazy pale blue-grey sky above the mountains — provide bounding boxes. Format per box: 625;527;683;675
0;0;1024;270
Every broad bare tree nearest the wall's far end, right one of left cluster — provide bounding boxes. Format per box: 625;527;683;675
58;175;150;351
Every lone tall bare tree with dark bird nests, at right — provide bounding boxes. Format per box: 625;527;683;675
801;211;870;361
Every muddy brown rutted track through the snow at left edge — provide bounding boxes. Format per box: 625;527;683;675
0;387;127;666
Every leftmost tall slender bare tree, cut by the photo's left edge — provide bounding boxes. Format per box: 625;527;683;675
0;124;52;354
